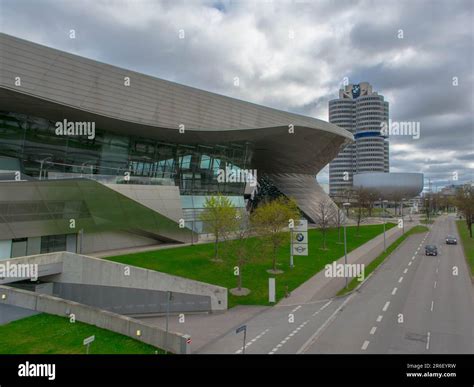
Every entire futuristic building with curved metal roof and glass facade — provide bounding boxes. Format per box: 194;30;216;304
0;34;353;259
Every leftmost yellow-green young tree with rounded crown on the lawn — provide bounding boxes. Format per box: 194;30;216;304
199;194;237;261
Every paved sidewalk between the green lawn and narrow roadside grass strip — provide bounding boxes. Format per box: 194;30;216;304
277;222;418;306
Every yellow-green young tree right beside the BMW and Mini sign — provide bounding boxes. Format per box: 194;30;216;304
251;196;300;274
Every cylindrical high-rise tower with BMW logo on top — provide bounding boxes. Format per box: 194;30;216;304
329;82;389;197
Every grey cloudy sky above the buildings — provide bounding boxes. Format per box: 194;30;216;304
0;0;474;189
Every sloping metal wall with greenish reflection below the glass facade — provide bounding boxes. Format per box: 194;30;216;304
0;179;191;242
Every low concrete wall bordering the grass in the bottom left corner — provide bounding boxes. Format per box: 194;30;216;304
0;286;191;353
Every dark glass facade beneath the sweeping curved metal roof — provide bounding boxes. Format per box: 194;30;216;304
0;112;252;195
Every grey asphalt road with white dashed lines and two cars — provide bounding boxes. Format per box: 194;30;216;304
198;216;474;354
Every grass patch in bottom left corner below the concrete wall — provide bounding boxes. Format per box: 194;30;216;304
0;314;163;354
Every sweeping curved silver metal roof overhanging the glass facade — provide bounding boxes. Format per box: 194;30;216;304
0;33;353;175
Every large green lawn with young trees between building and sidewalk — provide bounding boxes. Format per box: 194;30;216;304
105;223;394;308
